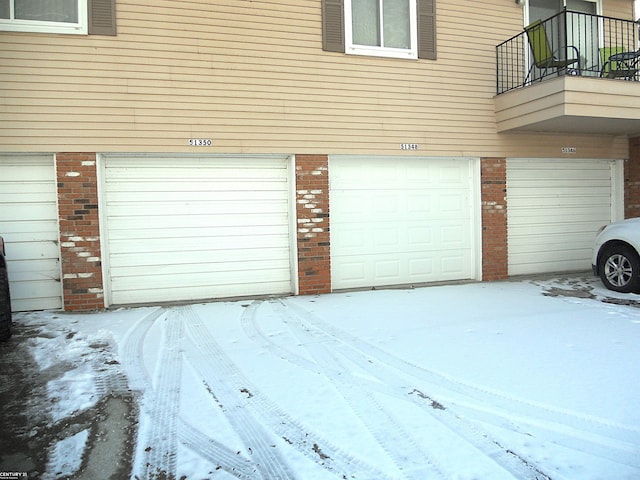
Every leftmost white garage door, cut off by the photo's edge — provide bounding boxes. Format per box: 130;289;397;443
0;155;62;311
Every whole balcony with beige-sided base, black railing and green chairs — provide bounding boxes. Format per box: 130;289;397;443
495;10;640;135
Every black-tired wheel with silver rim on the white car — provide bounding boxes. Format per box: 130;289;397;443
598;245;640;293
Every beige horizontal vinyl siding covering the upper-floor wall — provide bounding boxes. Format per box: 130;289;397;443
0;0;632;158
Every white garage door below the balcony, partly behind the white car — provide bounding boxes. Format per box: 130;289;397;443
507;159;622;275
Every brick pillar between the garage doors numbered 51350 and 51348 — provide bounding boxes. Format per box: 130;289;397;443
296;155;331;295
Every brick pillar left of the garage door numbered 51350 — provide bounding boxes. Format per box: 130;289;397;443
56;153;104;311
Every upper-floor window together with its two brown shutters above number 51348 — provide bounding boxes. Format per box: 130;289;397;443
322;0;436;60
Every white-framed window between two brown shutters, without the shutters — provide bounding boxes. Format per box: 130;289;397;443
345;0;418;58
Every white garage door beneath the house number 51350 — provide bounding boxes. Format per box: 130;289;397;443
104;156;292;305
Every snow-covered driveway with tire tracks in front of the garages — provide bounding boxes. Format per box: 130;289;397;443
2;277;640;480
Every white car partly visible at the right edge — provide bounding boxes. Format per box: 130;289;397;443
591;218;640;293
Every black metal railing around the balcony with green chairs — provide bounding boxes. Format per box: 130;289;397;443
496;10;640;94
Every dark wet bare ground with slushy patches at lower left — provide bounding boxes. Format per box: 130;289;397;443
0;316;138;479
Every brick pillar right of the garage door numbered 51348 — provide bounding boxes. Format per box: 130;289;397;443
480;158;509;281
